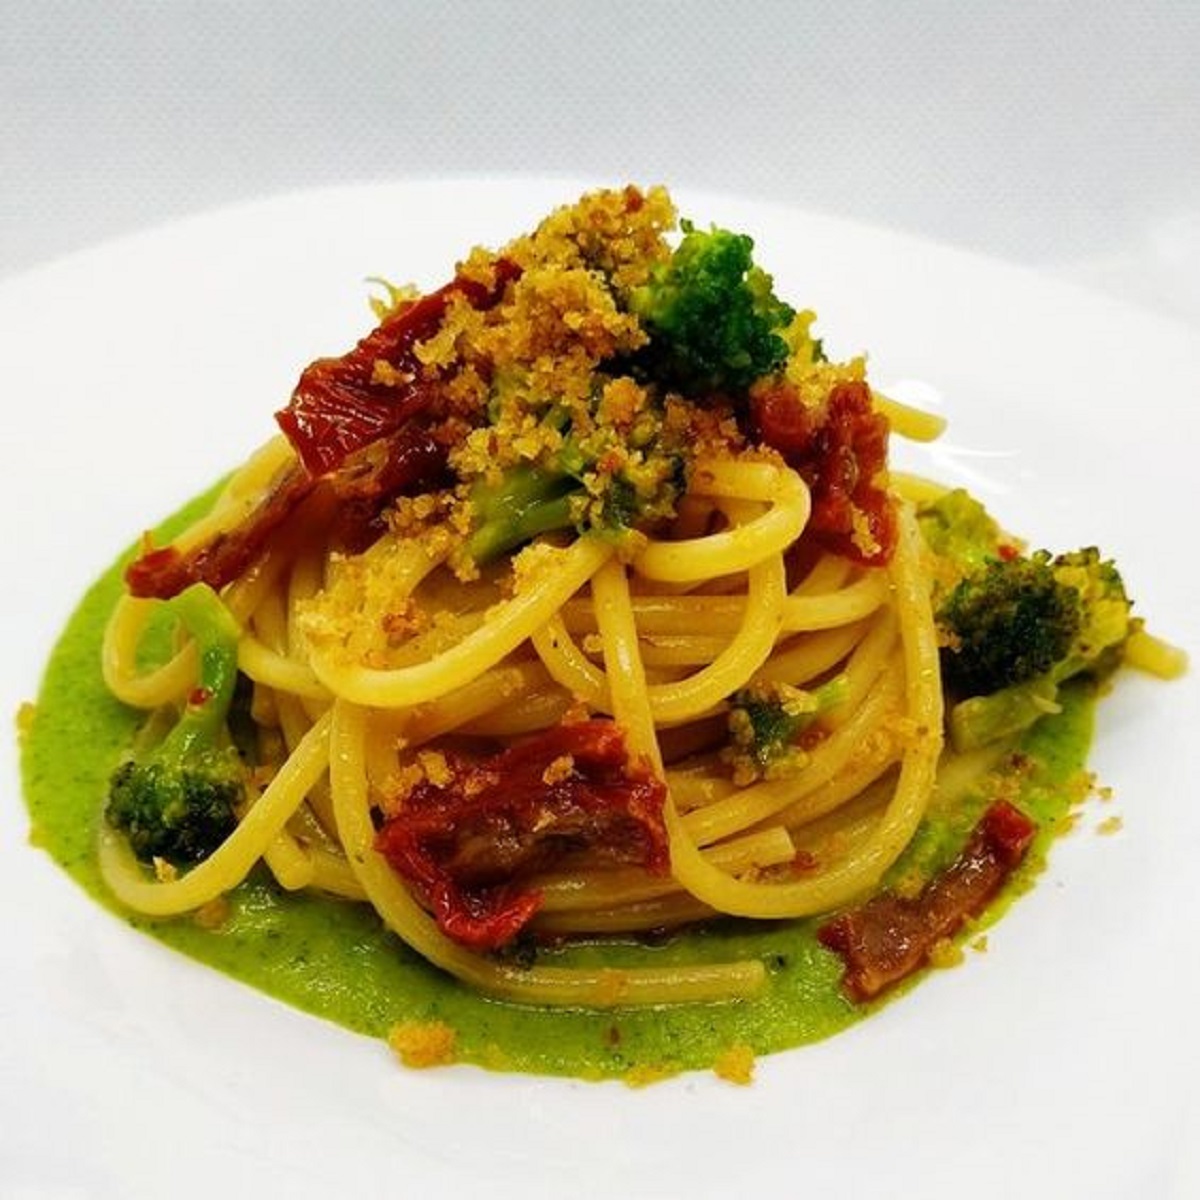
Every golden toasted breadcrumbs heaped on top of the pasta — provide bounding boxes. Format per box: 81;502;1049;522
296;186;878;670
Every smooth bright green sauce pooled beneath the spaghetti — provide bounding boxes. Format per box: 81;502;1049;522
22;484;1092;1078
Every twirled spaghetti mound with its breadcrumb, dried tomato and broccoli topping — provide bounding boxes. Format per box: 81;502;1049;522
100;187;1185;1007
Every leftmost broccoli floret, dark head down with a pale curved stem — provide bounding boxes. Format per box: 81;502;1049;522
104;583;244;865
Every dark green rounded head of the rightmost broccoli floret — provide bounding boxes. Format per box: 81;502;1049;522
937;553;1082;696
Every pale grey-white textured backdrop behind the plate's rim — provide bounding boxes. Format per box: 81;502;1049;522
7;0;1200;323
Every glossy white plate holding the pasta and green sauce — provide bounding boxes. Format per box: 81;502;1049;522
0;179;1200;1198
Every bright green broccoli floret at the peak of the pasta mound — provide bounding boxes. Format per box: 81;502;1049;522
629;221;796;395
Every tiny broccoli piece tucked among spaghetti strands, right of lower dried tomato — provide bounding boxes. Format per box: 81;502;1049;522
725;676;848;784
